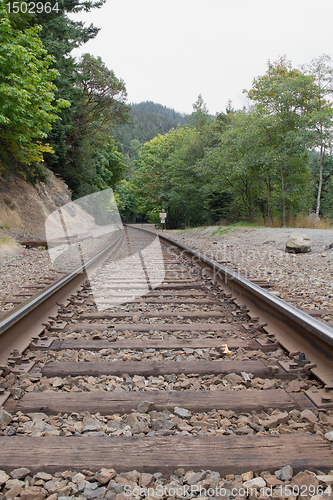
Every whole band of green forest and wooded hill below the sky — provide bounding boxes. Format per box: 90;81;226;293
0;0;333;228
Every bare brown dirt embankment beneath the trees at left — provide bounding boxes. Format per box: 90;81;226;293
0;170;71;241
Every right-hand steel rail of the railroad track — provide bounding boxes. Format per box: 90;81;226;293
125;224;333;388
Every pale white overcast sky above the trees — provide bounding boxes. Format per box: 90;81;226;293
71;0;333;114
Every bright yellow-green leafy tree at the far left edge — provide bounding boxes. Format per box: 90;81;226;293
0;0;70;176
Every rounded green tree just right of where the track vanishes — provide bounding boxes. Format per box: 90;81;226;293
134;126;206;227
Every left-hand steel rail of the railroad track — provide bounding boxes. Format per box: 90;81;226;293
0;227;123;363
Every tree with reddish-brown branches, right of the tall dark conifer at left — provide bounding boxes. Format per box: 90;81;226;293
44;54;129;197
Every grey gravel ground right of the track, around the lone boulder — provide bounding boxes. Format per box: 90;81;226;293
163;227;333;321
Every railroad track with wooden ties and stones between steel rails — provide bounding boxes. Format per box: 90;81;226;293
0;226;333;500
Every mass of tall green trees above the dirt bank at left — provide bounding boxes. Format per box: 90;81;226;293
0;0;129;196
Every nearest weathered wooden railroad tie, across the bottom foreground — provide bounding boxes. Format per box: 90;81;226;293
0;434;333;475
